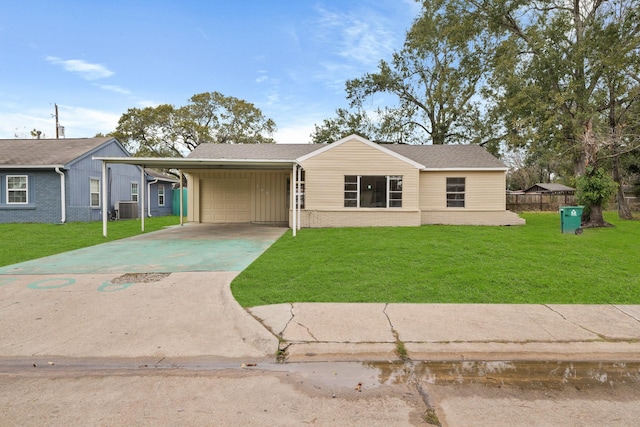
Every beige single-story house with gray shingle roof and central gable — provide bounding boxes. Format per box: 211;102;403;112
182;135;524;229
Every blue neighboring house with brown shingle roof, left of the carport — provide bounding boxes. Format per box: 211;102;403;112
0;138;142;223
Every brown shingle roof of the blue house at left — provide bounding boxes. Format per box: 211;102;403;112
0;137;117;168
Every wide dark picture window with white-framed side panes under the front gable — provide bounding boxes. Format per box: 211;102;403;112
344;175;402;208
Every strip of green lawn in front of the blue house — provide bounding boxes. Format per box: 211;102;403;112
0;216;180;267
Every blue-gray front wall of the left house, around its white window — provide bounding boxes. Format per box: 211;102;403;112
0;170;62;223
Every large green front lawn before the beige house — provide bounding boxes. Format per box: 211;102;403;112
231;213;640;307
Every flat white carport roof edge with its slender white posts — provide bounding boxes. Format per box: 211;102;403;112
93;157;302;237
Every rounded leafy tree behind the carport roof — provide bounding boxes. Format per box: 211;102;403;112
112;92;276;157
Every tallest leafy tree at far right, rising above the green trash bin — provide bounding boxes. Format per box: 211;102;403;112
462;0;640;223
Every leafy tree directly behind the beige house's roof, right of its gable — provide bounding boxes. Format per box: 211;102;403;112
346;0;490;144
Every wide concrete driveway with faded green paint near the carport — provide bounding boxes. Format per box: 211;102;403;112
0;224;286;360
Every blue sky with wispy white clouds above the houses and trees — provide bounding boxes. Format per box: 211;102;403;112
0;0;420;143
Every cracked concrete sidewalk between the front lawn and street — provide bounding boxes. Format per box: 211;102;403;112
249;303;640;362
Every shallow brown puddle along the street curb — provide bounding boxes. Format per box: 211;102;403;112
262;361;640;389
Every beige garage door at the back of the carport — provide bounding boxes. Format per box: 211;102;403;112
200;178;251;223
